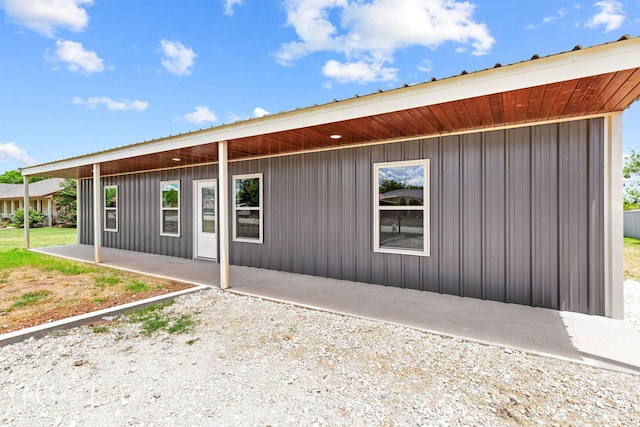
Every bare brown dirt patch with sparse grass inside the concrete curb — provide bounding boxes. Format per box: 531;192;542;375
0;267;192;334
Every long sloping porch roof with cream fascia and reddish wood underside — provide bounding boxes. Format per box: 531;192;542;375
22;36;640;178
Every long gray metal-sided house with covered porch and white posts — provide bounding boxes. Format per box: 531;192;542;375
22;37;640;321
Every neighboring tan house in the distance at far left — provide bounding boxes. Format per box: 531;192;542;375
0;178;64;227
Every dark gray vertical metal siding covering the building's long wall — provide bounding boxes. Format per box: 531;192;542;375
81;118;605;315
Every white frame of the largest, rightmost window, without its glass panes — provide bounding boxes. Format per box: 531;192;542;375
373;159;431;257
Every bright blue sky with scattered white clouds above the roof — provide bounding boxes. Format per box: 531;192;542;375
0;0;640;173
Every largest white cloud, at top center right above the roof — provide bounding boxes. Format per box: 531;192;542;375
276;0;495;82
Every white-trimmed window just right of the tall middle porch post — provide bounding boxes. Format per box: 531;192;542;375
233;173;263;243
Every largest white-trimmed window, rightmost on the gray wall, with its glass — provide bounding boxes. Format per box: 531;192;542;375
373;159;429;256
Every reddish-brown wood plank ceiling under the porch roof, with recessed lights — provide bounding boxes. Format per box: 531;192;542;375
66;68;640;178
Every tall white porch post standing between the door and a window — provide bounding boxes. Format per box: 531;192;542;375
218;141;229;289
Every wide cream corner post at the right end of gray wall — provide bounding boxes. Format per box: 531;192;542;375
604;113;624;319
